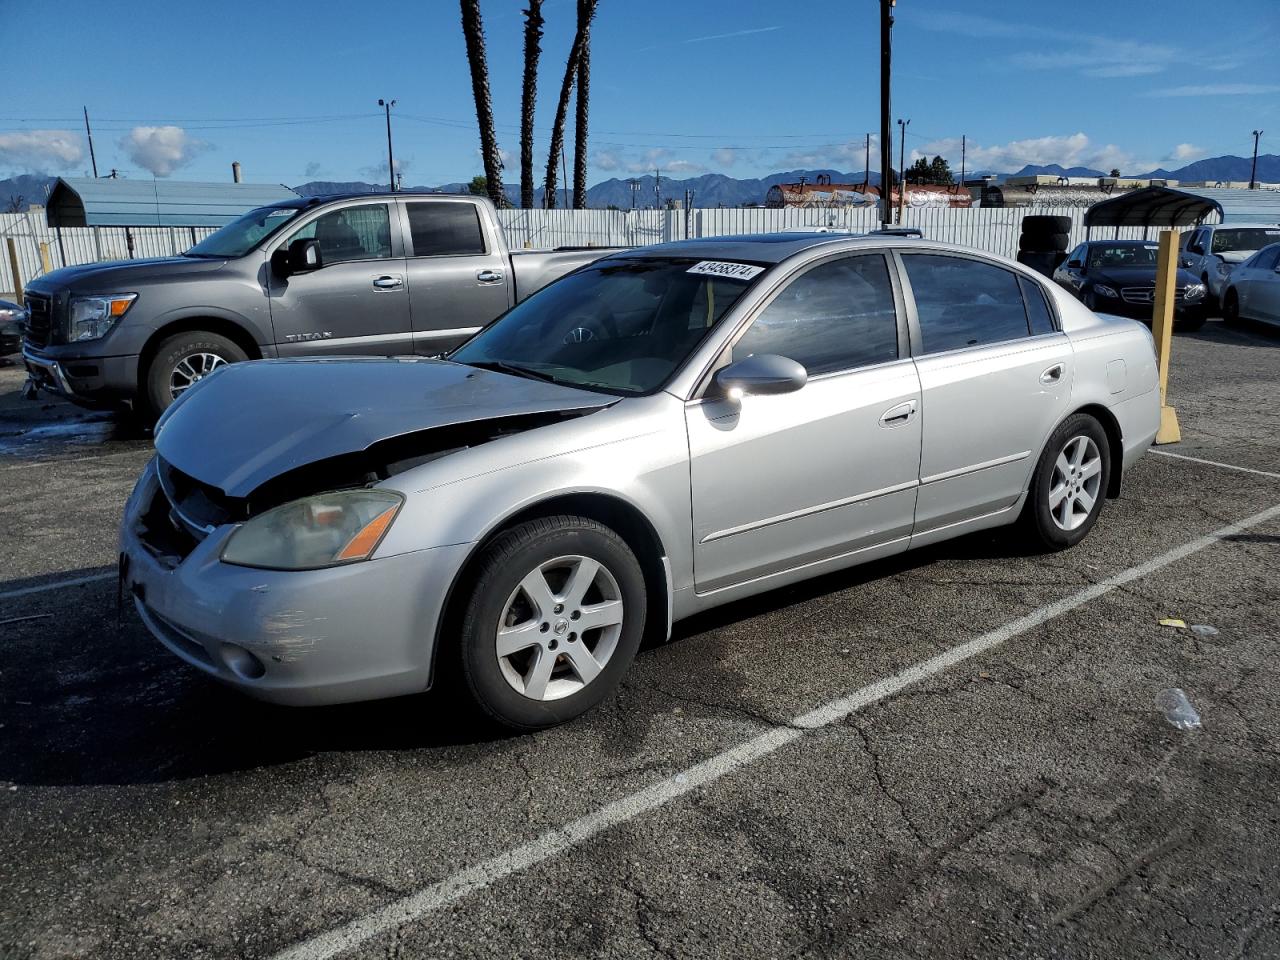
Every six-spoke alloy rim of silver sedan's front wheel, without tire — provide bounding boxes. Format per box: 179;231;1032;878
494;556;625;700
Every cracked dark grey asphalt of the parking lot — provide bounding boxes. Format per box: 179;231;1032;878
0;323;1280;960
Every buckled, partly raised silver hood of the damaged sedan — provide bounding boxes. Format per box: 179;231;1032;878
156;357;617;498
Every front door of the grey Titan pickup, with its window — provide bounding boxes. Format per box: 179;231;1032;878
269;202;413;357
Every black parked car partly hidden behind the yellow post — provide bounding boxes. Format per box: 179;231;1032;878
1053;241;1210;330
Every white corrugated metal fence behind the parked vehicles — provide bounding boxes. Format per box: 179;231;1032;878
0;207;1192;297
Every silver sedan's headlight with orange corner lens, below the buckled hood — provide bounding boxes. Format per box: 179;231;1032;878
221;490;404;570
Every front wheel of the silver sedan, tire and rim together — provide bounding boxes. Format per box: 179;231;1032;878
458;516;646;731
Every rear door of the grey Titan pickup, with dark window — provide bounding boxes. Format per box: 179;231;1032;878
401;197;515;356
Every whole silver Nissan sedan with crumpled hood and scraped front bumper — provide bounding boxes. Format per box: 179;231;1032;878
120;234;1160;730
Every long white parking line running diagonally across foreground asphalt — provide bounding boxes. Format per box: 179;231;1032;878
273;504;1280;960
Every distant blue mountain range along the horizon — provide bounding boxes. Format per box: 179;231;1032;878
0;154;1280;211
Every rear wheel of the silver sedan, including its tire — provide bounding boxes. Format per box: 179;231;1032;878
1023;413;1111;550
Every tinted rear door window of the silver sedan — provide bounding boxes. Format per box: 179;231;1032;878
902;253;1030;353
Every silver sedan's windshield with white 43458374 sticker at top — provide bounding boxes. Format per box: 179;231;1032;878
449;259;764;394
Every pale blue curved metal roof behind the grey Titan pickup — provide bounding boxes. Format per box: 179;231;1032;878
45;177;298;227
